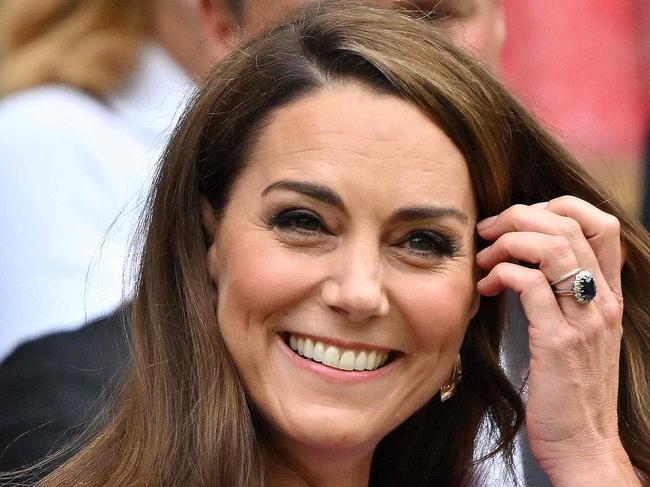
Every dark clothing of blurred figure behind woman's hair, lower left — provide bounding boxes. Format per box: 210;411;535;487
0;310;129;476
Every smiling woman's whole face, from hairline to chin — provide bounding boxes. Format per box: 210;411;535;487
203;84;478;462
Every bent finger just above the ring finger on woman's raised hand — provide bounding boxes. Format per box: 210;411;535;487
477;205;607;287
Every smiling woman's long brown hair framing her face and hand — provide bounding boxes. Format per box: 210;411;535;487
29;3;650;487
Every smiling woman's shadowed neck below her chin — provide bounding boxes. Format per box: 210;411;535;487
264;443;374;487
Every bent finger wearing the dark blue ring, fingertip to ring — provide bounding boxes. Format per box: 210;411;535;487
476;232;580;281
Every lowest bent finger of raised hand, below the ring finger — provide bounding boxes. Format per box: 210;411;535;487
476;262;566;333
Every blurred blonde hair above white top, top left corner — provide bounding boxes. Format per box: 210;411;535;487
0;0;149;97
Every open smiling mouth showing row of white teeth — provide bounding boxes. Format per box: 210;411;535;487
282;333;397;372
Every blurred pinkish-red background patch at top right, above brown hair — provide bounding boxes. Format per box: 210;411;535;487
502;0;650;214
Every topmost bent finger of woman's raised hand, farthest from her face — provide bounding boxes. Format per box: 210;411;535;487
546;196;623;296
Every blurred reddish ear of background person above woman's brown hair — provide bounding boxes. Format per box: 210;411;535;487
199;0;238;62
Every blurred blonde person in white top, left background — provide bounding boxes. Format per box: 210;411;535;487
0;0;260;360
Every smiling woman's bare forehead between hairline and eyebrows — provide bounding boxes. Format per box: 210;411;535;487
244;83;474;219
